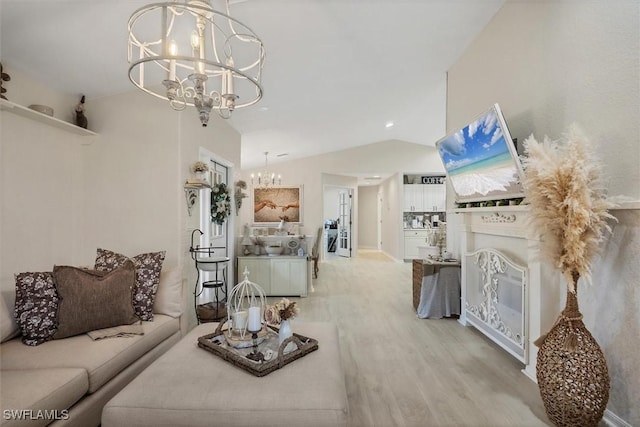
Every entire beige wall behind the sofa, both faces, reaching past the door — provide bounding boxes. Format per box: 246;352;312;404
0;64;240;334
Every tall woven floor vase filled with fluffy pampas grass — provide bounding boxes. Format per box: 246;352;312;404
524;126;614;427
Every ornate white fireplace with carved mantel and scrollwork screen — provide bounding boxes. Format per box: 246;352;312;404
448;206;564;381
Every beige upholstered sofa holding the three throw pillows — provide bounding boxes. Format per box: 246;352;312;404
0;270;183;427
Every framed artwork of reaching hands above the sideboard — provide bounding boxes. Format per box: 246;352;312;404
251;185;303;225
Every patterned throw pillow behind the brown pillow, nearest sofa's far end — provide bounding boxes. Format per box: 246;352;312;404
95;248;166;320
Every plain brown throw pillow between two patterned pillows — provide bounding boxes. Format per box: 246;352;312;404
53;260;138;339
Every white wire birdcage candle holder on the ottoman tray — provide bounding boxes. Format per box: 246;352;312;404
227;268;266;340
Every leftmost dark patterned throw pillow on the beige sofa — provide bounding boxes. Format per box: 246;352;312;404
14;272;60;345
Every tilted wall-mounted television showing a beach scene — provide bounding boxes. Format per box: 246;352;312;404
436;104;524;203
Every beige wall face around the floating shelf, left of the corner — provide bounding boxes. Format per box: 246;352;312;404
0;64;86;291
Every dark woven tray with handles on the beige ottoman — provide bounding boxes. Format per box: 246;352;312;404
198;322;318;377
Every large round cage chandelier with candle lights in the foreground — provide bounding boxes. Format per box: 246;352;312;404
128;0;265;126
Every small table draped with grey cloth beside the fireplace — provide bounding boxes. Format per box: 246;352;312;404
413;259;460;319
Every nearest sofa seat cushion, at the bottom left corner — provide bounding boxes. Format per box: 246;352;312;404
0;368;89;427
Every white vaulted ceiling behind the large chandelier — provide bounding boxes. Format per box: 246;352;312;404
0;0;505;169
